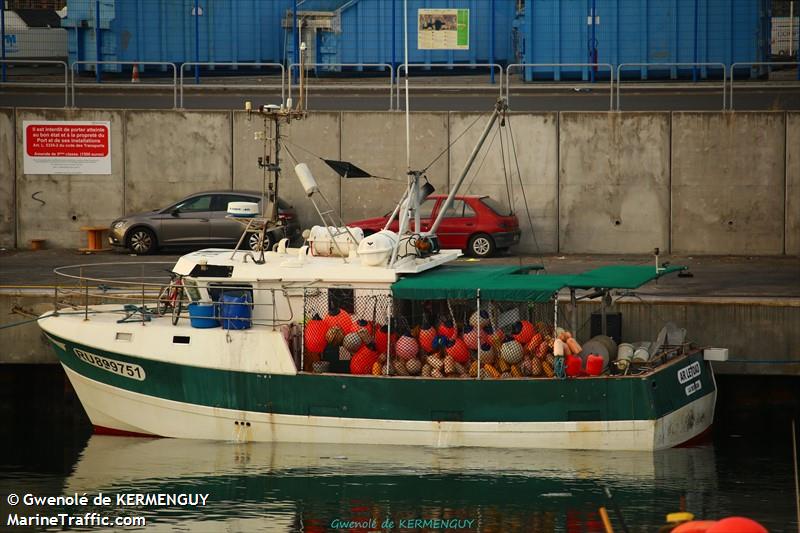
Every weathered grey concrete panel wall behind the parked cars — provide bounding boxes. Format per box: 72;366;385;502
0;108;800;255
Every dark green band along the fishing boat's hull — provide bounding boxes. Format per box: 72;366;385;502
47;337;714;422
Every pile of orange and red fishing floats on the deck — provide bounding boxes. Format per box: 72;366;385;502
304;309;603;379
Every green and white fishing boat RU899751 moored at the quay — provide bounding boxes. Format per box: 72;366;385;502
39;14;716;450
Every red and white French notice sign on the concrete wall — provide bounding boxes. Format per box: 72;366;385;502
22;120;111;174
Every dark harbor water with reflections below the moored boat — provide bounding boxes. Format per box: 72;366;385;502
0;367;797;532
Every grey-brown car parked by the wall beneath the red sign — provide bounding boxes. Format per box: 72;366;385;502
108;190;300;255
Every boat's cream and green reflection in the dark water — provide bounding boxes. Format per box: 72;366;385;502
64;435;716;532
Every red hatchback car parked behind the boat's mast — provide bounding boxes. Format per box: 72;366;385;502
347;194;520;257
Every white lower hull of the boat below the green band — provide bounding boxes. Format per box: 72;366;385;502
64;365;716;450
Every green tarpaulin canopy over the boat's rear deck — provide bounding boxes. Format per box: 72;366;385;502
392;265;685;302
